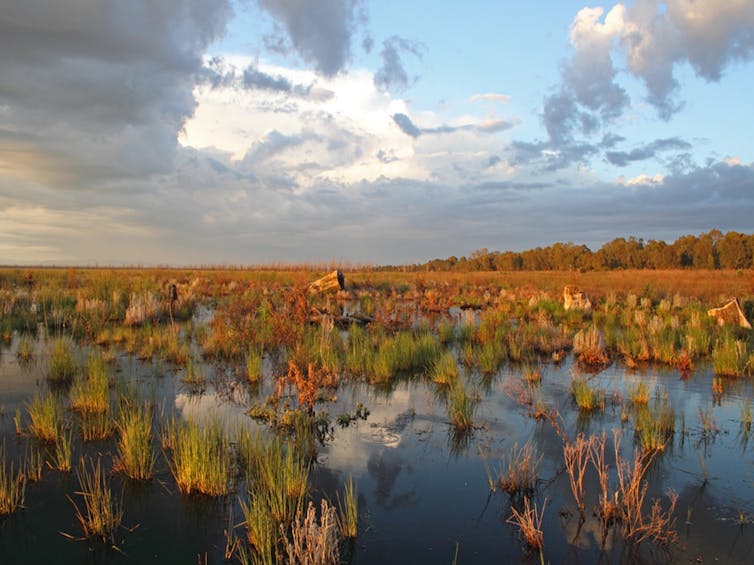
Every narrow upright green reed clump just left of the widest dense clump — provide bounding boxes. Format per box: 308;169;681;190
115;406;155;481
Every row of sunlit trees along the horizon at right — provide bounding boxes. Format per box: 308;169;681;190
402;230;754;271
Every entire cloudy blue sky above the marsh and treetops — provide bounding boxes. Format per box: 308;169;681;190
0;0;754;266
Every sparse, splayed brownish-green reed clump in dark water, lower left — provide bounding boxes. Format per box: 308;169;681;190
71;458;123;544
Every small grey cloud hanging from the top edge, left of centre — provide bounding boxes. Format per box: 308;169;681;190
258;0;363;76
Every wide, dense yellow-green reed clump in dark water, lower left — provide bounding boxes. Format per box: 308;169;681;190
170;420;232;496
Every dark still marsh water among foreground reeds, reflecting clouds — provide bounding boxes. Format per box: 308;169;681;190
0;332;754;564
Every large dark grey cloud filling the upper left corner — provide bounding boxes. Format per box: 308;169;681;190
0;0;231;188
